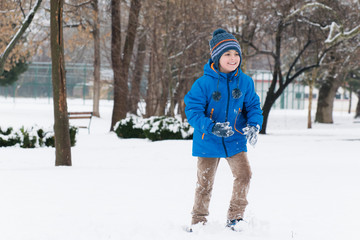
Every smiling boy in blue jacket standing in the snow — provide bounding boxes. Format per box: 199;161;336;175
184;29;263;231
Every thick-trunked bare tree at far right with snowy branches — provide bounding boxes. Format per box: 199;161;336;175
315;1;360;123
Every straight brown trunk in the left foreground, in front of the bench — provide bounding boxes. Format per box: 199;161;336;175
50;0;71;166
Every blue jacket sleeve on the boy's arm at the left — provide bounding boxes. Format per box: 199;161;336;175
184;79;214;134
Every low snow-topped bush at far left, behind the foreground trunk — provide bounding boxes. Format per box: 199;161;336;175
0;127;78;148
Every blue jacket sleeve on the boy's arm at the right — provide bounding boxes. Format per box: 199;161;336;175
244;77;263;130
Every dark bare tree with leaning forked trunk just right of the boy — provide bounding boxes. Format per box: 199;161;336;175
252;1;329;134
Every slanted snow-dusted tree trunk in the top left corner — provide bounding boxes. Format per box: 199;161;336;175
0;0;42;76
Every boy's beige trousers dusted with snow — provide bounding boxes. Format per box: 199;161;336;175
191;152;251;225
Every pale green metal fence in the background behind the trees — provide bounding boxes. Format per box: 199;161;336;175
0;62;305;109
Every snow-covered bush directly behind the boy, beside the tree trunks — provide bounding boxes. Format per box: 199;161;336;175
114;115;194;141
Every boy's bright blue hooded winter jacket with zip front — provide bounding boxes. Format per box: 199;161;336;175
184;60;263;158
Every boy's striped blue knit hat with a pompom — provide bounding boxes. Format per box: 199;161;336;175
209;28;242;68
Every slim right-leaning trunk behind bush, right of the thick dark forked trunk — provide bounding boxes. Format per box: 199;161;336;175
129;31;147;114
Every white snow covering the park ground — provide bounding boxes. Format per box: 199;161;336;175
0;98;360;240
